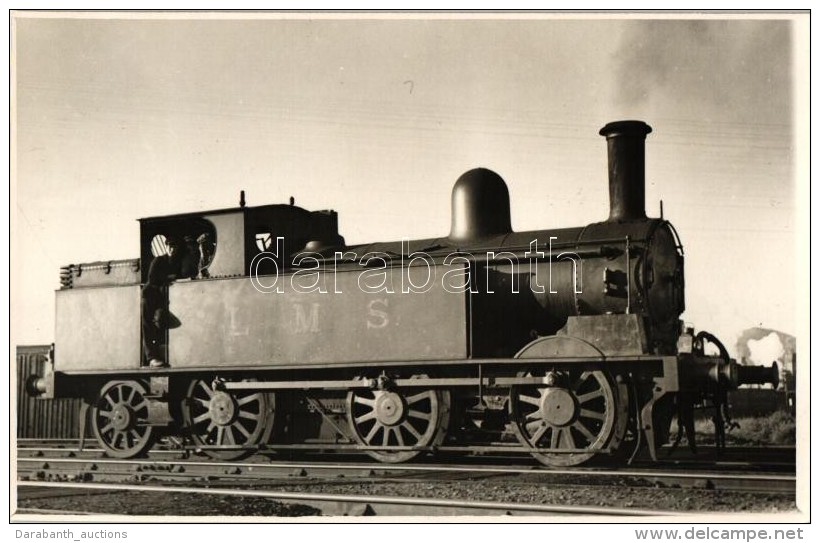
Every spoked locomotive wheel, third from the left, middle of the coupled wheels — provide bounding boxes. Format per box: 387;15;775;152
347;378;450;463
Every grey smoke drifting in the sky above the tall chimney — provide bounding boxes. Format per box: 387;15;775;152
613;20;792;124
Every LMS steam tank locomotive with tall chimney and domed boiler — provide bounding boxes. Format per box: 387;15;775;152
28;121;777;466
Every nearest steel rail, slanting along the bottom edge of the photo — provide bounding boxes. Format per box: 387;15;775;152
17;481;681;516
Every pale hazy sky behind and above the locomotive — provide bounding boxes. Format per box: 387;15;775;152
11;14;808;349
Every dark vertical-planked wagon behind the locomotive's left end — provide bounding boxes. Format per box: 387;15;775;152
17;345;81;439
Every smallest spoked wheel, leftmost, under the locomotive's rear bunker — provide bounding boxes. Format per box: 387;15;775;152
91;381;154;458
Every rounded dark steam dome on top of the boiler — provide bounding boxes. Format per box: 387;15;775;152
450;168;512;241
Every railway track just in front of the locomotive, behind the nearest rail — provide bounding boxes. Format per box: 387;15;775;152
17;455;796;493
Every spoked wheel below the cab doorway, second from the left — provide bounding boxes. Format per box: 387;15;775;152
182;379;274;460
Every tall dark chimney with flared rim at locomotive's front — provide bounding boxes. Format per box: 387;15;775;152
599;121;652;221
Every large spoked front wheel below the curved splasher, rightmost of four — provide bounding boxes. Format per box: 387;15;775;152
510;370;623;467
